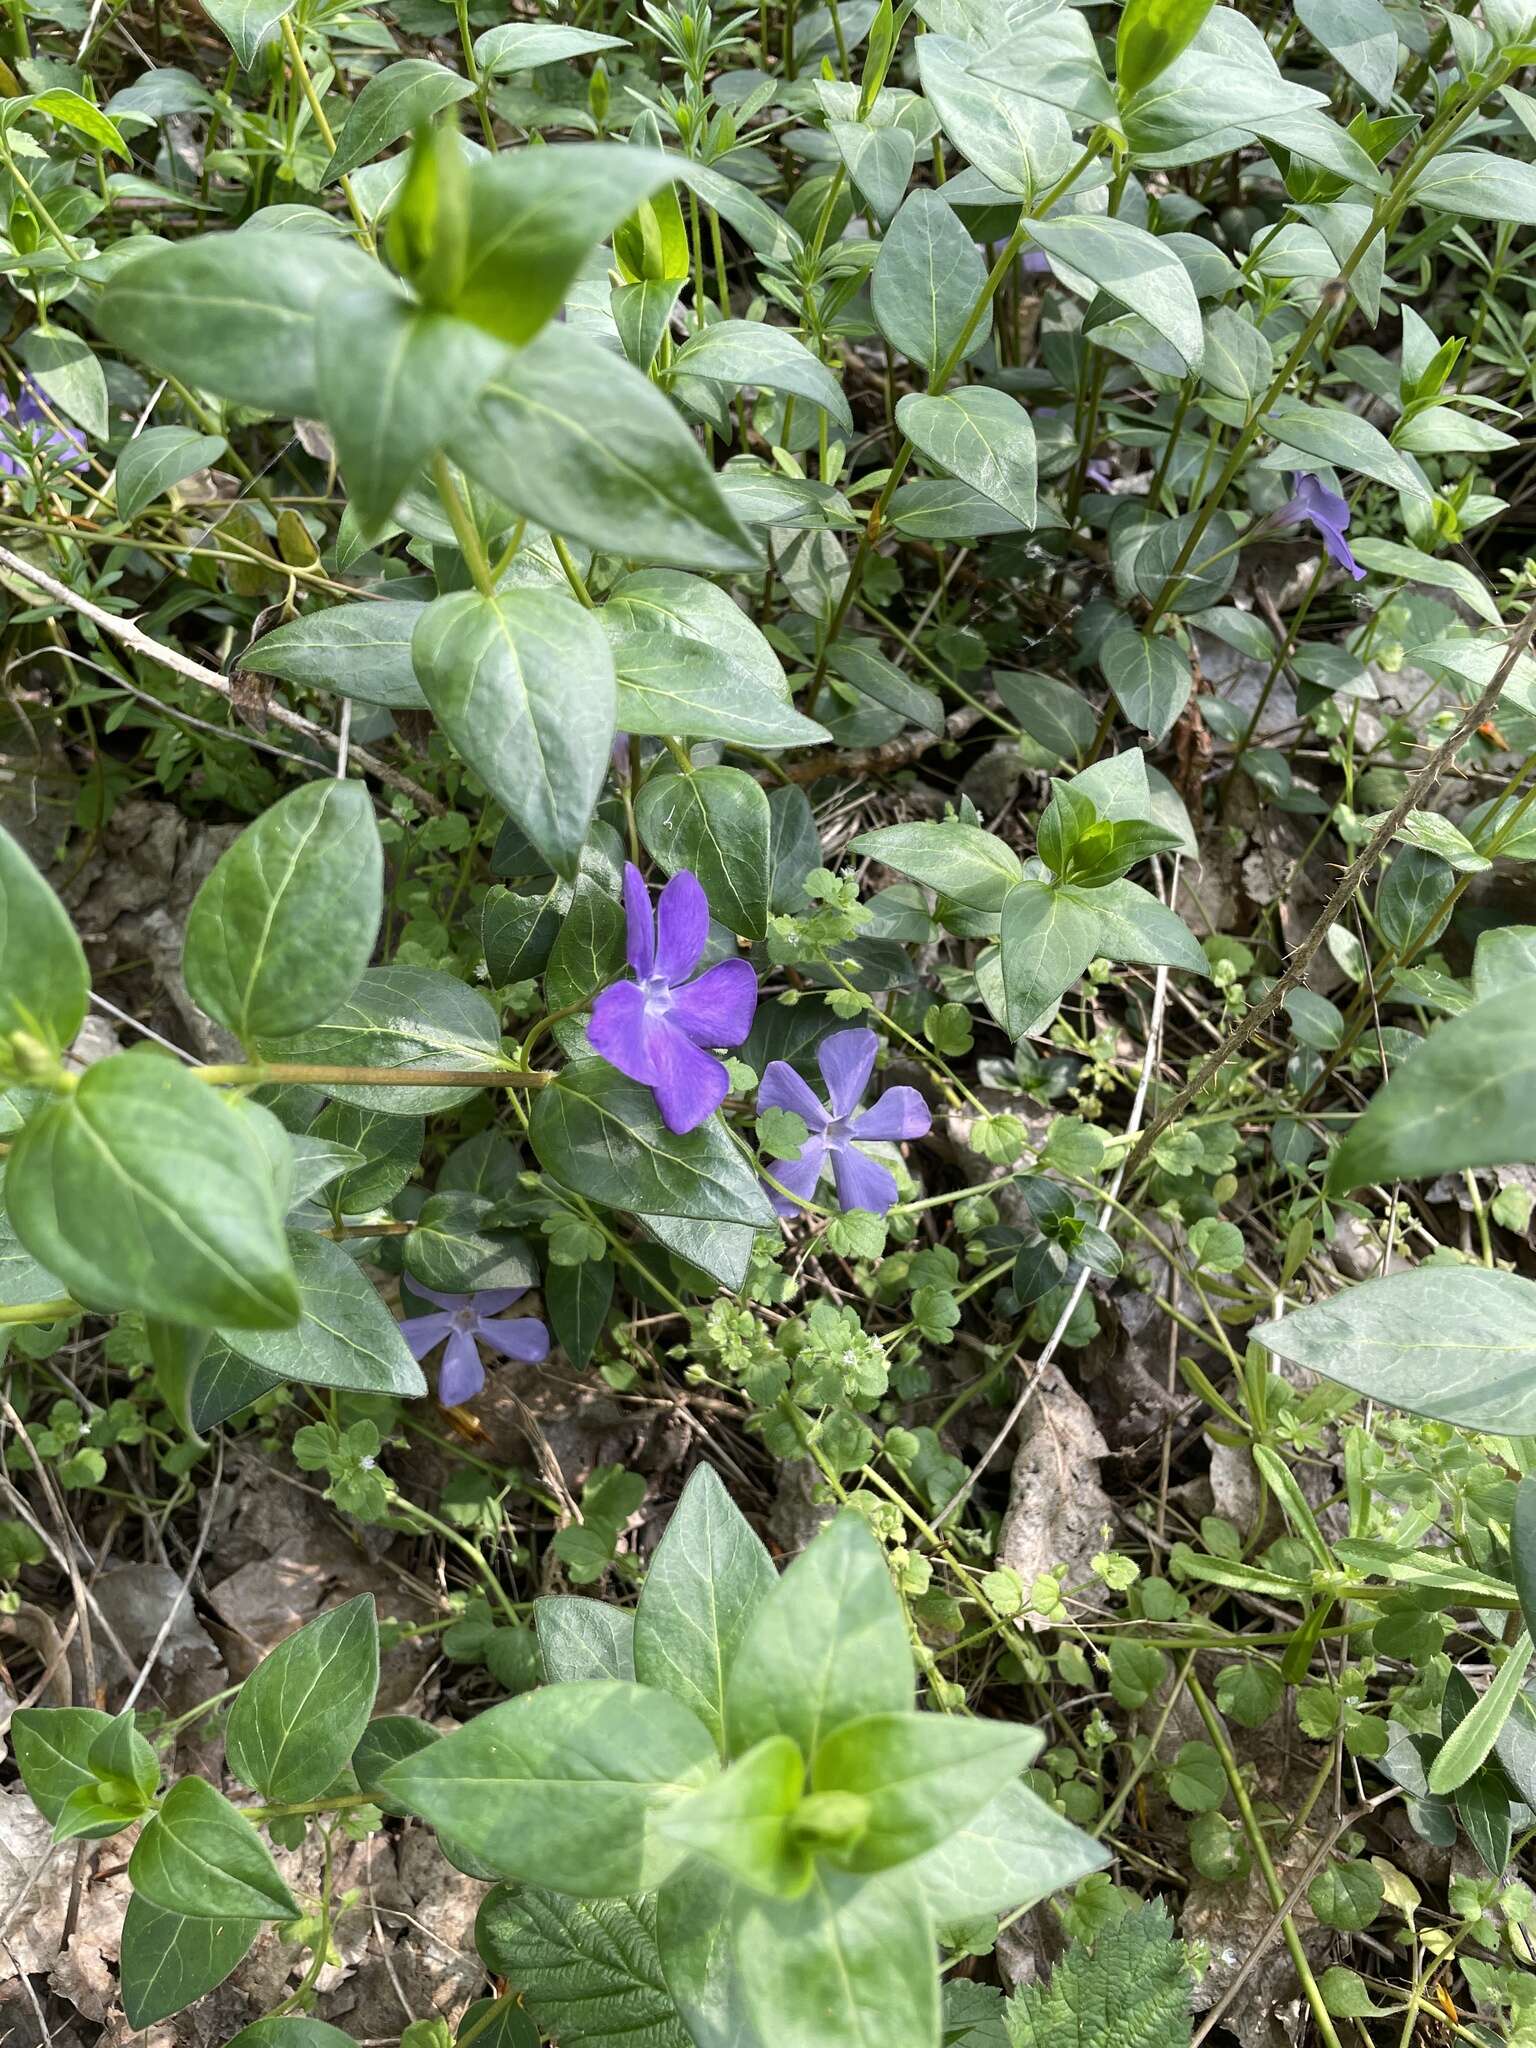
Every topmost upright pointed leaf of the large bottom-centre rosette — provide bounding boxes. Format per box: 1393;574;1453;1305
635;1464;778;1743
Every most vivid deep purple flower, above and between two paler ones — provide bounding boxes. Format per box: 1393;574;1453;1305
586;864;758;1135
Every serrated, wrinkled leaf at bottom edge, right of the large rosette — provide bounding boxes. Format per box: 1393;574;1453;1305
1008;1901;1194;2048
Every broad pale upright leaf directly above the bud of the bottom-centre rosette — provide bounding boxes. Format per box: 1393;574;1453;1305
725;1511;913;1757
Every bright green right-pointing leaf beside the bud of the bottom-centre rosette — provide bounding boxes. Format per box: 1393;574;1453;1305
811;1714;1042;1870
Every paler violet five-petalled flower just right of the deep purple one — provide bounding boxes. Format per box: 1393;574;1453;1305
758;1030;934;1217
